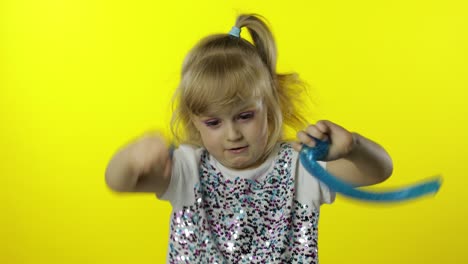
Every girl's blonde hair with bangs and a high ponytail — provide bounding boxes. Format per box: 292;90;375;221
171;14;307;159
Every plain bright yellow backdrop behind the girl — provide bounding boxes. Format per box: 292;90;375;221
0;0;468;264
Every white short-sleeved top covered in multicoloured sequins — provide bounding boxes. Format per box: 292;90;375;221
161;143;334;263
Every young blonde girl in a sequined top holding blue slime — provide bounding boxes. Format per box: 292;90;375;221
106;14;392;263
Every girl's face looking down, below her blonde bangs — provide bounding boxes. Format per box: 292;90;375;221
193;101;268;169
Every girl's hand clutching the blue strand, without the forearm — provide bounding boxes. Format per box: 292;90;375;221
293;120;355;161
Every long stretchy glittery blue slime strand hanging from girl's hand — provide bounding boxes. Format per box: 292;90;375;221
299;138;442;202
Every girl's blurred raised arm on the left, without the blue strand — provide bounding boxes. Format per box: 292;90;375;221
105;135;172;196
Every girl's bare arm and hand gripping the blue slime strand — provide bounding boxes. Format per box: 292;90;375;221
294;120;393;186
